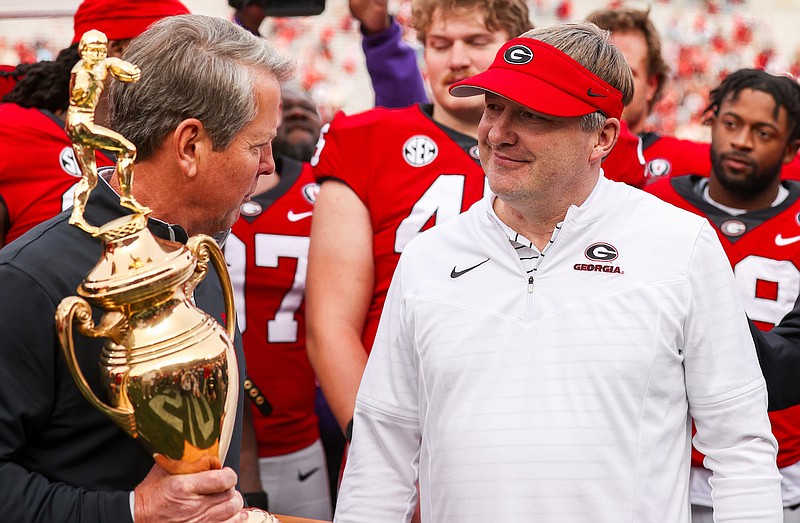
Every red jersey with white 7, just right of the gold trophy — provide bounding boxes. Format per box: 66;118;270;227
225;158;319;457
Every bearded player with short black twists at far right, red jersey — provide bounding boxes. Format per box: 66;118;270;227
648;69;800;523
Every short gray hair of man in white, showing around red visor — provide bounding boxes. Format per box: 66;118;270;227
520;22;633;131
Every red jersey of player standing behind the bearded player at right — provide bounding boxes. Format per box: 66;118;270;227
642;133;800;184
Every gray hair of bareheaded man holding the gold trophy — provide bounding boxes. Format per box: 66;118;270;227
109;15;295;160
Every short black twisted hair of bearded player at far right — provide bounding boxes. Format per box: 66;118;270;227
706;69;800;141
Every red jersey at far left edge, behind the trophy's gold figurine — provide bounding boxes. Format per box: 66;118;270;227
0;103;114;247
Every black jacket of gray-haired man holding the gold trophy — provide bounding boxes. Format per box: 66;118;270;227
0;181;244;523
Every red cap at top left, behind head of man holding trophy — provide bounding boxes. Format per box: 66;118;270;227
72;0;189;44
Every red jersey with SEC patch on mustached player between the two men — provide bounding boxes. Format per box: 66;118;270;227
311;105;486;352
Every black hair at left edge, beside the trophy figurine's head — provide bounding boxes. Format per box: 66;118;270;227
0;43;81;113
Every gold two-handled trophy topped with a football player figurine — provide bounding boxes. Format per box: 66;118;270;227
56;31;239;474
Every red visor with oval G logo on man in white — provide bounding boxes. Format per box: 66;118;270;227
450;38;623;118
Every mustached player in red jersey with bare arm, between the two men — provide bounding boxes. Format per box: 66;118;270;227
307;0;531;448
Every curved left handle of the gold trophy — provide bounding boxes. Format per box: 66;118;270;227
56;296;136;437
